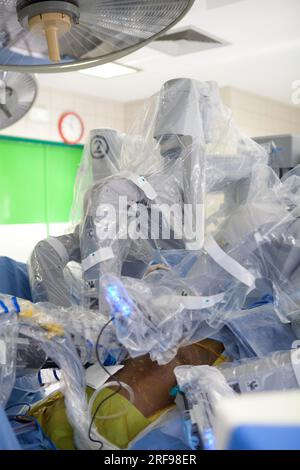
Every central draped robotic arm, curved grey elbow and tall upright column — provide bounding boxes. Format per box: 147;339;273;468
80;79;216;288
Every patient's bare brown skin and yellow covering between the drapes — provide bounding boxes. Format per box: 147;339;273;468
31;339;223;450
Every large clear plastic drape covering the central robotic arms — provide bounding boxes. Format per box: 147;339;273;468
27;79;299;363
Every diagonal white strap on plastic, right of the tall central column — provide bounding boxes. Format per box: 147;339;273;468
204;237;255;287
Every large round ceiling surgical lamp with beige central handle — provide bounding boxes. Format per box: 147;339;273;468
0;0;194;72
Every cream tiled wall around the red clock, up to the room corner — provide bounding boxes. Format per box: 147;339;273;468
0;88;125;143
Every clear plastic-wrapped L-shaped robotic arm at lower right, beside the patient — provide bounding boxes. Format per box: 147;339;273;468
175;349;300;450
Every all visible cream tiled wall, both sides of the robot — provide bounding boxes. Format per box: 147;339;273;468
0;82;300;143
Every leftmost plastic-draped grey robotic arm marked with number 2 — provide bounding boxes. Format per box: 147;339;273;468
28;129;127;307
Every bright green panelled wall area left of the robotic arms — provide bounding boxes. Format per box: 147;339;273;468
0;137;82;224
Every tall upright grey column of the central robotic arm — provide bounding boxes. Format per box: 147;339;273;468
154;78;219;250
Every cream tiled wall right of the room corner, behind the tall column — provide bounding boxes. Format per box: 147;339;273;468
125;87;300;137
